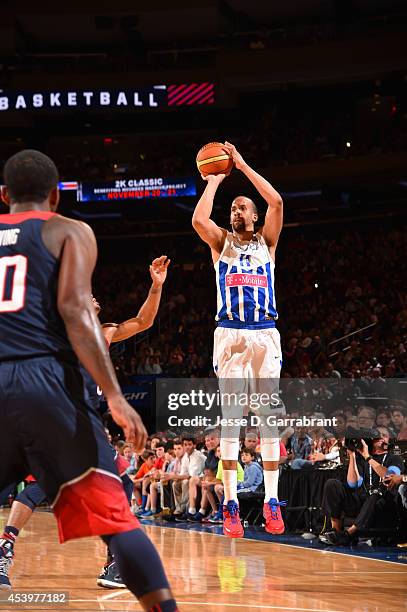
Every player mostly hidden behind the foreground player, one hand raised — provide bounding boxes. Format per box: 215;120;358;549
0;260;170;589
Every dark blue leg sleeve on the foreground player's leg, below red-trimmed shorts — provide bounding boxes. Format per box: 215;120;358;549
102;529;170;598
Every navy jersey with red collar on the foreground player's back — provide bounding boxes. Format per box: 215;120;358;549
0;211;77;363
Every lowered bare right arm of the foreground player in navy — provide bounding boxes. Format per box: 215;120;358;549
49;217;147;449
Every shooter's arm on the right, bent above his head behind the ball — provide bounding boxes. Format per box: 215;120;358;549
225;142;283;255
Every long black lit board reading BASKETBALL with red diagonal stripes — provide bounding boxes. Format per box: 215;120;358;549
0;83;215;113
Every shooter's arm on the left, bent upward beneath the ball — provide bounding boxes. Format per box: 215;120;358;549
192;174;227;255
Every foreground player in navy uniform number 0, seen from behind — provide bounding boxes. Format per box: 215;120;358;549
0;150;177;611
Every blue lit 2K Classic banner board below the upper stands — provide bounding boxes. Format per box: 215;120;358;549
76;177;196;202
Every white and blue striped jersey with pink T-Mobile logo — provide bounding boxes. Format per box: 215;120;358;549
215;232;278;329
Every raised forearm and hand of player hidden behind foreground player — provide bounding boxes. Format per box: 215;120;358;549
111;255;170;342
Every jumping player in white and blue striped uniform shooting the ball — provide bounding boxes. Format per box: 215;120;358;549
192;142;284;538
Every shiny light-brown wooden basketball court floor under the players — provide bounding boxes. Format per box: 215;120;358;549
0;510;407;612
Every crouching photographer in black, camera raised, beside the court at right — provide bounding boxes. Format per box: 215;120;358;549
319;430;404;546
